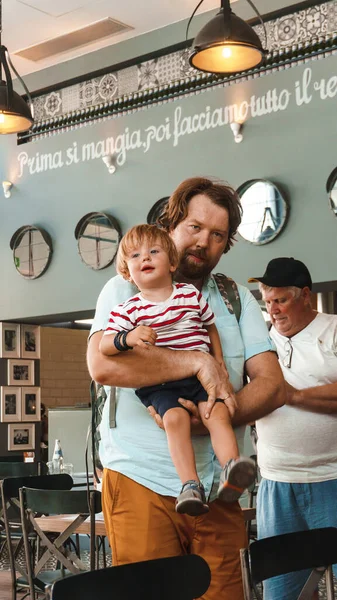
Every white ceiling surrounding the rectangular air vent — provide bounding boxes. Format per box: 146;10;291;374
2;0;292;75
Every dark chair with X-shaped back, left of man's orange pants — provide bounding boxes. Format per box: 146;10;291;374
20;488;102;600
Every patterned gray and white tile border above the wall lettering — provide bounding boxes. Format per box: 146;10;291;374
18;0;337;143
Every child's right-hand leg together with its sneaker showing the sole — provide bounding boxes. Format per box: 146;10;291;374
199;402;256;502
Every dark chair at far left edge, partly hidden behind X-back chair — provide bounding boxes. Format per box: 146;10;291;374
0;474;72;600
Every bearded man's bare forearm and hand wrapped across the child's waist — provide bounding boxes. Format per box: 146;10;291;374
87;331;232;400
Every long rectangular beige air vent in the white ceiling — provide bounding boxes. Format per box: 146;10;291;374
13;17;133;62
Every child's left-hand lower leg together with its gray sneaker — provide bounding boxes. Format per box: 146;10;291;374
163;408;209;516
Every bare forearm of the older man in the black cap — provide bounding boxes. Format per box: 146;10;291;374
286;382;337;414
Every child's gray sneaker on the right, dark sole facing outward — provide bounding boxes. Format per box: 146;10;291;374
218;456;256;502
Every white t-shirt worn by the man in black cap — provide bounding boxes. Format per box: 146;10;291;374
256;313;337;483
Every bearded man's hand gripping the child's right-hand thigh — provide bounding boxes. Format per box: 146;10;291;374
197;354;237;419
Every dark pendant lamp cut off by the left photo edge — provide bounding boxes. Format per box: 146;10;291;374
0;0;34;134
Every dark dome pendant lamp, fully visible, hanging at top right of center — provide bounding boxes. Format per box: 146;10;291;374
186;0;267;75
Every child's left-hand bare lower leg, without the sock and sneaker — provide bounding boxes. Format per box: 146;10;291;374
163;408;199;483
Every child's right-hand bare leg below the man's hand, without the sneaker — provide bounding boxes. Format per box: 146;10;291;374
198;402;239;467
